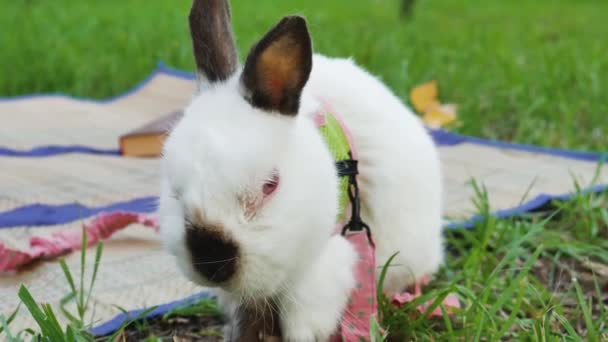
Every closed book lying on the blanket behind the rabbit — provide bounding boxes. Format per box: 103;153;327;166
119;111;183;157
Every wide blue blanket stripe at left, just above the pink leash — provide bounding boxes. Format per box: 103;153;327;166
0;197;158;229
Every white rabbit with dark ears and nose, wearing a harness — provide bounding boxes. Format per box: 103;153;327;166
159;0;443;341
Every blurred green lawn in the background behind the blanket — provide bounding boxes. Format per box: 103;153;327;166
0;0;608;150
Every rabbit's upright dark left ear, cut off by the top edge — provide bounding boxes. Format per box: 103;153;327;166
189;0;238;88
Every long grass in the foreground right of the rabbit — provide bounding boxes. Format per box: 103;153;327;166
381;179;608;341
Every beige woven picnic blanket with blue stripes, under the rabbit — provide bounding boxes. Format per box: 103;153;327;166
0;64;608;334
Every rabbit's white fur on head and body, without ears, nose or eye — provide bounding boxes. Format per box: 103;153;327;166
160;55;443;341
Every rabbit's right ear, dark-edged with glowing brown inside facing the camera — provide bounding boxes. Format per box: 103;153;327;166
241;16;312;116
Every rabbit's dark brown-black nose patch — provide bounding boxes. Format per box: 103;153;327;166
186;228;238;283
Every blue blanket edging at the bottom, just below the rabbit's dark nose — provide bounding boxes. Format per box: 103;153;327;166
89;291;215;337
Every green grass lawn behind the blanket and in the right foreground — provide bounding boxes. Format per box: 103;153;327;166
0;0;608;341
